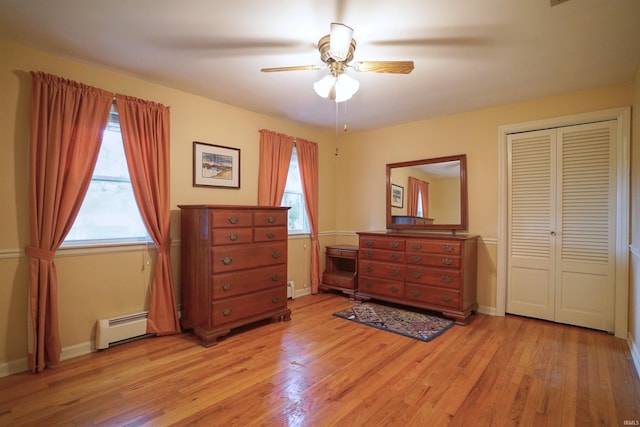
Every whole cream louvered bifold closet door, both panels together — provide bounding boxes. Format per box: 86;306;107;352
507;121;617;331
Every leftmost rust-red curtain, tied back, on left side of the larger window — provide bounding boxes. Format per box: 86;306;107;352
26;72;112;372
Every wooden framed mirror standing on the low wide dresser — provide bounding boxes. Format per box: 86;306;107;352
387;154;467;231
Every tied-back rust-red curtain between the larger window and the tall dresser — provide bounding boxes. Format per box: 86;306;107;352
116;95;180;335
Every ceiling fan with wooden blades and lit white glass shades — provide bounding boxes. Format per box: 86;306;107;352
260;22;414;102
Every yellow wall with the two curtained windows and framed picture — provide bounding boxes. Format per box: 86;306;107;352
0;40;337;376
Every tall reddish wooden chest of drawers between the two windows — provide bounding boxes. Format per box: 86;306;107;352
178;205;291;347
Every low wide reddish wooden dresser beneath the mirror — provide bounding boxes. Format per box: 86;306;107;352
356;232;478;325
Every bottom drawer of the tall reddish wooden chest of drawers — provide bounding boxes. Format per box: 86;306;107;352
211;286;287;327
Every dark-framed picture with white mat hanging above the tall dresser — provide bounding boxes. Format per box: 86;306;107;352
193;141;240;188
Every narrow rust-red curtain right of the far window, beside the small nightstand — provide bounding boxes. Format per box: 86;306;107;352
296;138;322;294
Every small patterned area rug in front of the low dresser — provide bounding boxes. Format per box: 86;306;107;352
333;302;455;341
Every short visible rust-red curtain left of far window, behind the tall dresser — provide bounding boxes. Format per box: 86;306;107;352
258;129;294;206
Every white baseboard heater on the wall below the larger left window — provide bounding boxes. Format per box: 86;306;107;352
96;311;154;350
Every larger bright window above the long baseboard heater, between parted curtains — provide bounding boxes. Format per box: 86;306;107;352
63;104;150;246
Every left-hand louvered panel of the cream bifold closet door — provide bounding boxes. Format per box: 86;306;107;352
507;131;556;320
